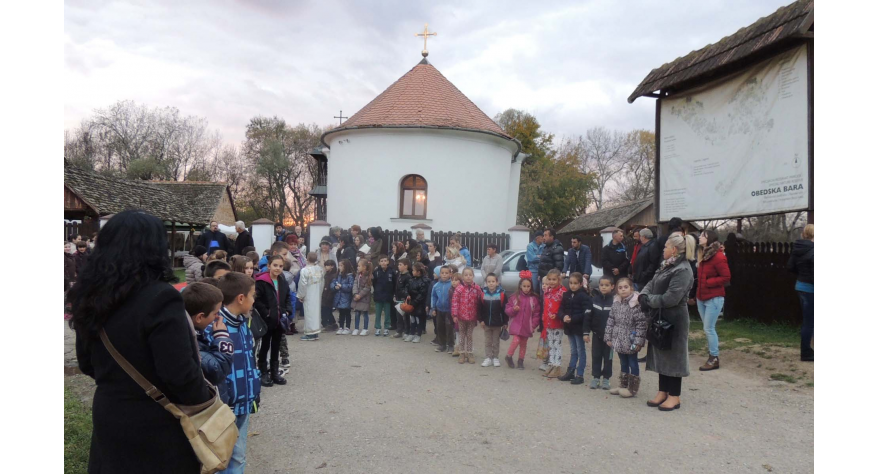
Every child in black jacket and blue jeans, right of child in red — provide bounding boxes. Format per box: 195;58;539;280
559;272;593;385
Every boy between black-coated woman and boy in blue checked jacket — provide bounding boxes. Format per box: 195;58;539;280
181;283;234;403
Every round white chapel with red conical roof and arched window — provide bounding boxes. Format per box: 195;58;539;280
311;45;526;241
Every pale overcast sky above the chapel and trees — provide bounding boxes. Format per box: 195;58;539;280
64;0;791;143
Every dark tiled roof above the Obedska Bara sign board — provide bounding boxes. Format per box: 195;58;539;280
627;0;813;103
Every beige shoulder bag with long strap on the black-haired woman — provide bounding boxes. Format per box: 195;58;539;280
101;329;238;474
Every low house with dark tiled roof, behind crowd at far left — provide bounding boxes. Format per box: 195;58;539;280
64;167;236;241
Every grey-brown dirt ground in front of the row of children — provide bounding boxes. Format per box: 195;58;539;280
65;323;814;473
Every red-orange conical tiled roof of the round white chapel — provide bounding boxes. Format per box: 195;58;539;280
328;59;512;140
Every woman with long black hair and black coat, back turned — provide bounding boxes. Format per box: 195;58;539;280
68;211;212;474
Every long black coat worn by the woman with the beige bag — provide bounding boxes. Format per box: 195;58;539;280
76;282;211;474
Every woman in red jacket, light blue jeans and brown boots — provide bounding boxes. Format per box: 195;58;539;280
697;230;730;371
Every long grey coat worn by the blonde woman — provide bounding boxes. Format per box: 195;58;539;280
640;255;694;377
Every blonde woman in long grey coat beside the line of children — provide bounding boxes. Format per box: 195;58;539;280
639;234;694;411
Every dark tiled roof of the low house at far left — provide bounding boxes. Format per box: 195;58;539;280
64;167;226;225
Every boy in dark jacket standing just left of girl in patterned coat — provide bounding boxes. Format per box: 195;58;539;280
583;275;614;390
